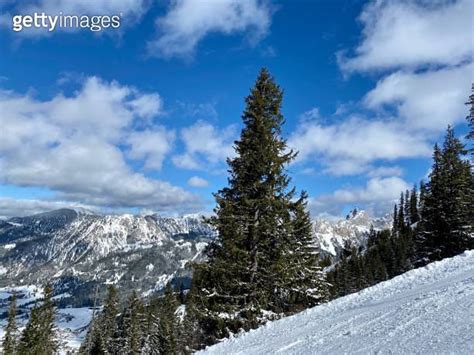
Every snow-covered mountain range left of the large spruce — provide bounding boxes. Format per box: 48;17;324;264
0;209;214;301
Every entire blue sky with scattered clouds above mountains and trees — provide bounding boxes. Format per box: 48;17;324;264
0;0;473;216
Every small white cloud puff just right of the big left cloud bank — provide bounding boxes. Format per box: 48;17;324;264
127;126;176;170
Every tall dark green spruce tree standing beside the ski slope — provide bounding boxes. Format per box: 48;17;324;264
193;69;328;343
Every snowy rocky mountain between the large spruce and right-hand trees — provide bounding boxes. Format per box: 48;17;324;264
314;209;392;261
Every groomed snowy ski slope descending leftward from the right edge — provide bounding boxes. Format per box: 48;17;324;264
202;250;474;355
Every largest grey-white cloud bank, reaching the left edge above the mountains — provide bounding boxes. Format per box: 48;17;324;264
0;77;199;211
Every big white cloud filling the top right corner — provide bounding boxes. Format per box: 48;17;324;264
340;0;474;71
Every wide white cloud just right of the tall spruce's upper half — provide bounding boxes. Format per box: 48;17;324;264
288;116;431;175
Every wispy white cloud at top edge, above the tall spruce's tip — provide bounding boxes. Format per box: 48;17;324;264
148;0;271;58
